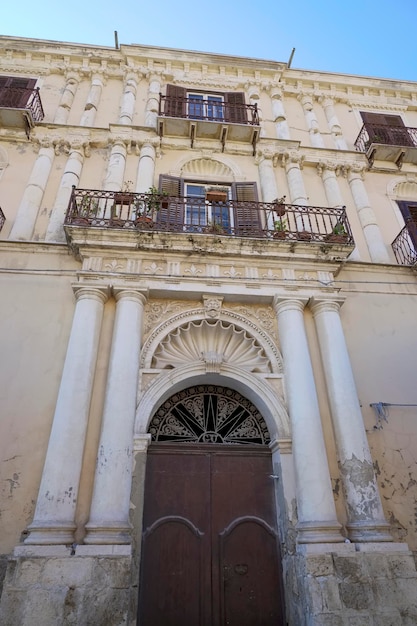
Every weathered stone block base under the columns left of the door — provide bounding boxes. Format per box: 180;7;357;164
0;546;131;626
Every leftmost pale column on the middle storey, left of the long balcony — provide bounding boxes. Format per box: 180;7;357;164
9;140;54;240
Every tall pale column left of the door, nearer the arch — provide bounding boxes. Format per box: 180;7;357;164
84;289;146;544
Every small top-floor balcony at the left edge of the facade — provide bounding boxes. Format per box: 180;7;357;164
0;85;44;137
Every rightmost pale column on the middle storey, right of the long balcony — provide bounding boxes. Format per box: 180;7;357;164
347;165;391;263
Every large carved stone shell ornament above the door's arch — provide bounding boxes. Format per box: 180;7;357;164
152;320;272;373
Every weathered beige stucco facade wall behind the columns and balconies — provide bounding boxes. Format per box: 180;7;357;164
0;37;417;564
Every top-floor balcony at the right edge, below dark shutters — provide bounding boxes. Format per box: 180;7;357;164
355;123;417;168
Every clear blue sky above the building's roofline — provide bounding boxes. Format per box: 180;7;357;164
1;0;417;81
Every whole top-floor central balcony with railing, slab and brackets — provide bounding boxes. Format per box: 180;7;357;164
158;94;260;153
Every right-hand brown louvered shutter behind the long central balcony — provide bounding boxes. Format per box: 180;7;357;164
232;183;262;237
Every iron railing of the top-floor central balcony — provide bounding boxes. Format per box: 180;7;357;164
159;94;259;126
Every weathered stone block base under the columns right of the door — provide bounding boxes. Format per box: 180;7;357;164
285;544;417;626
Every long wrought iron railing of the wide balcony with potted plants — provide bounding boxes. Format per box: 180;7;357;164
65;188;354;247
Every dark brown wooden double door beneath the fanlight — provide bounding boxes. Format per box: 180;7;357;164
138;444;286;626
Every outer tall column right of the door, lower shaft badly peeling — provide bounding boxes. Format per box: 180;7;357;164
310;298;392;542
